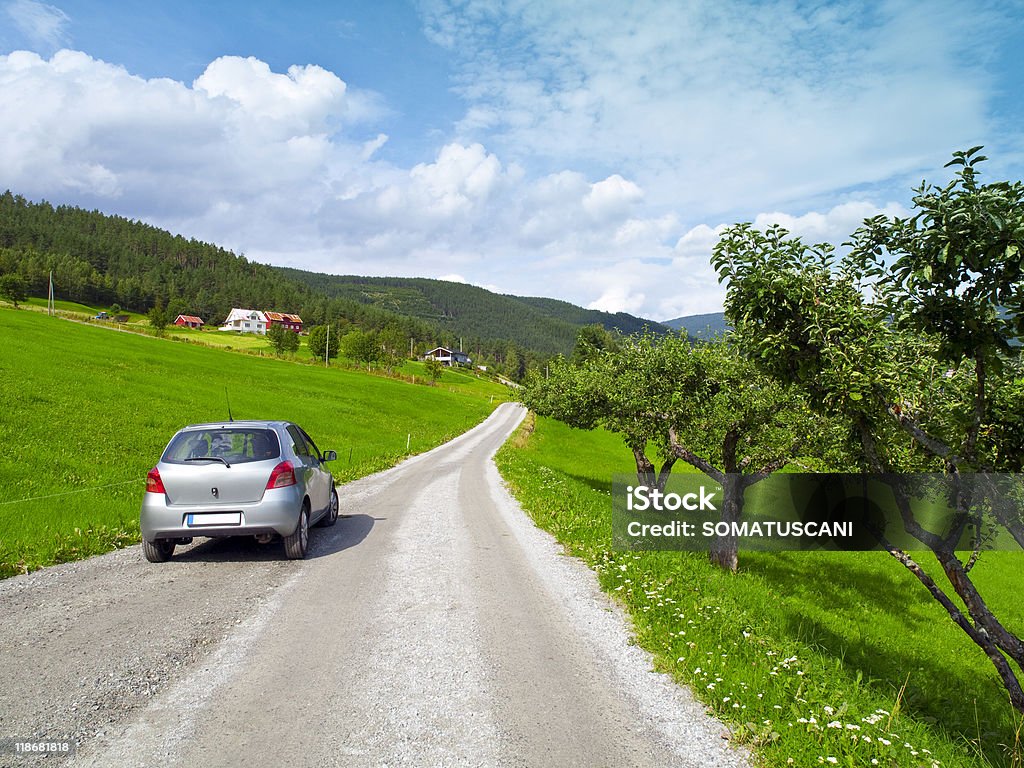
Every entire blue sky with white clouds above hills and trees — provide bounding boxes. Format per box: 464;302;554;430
0;0;1024;319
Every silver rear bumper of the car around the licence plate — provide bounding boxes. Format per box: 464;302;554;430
139;485;303;542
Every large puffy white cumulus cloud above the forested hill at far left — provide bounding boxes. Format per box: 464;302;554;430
0;50;380;231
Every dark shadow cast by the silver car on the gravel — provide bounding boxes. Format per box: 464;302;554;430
174;515;387;562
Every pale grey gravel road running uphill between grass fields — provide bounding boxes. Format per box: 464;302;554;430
0;404;748;768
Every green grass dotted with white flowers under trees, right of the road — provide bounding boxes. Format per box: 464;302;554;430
498;419;1024;768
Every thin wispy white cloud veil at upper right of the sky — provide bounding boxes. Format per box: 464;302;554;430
425;0;1012;219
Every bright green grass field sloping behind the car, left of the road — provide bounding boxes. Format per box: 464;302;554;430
0;308;504;575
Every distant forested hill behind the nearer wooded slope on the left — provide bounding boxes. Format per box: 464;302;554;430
281;269;668;353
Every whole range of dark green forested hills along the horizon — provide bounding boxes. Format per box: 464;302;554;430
0;191;660;361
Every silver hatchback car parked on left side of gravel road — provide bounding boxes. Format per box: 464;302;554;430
140;421;338;562
